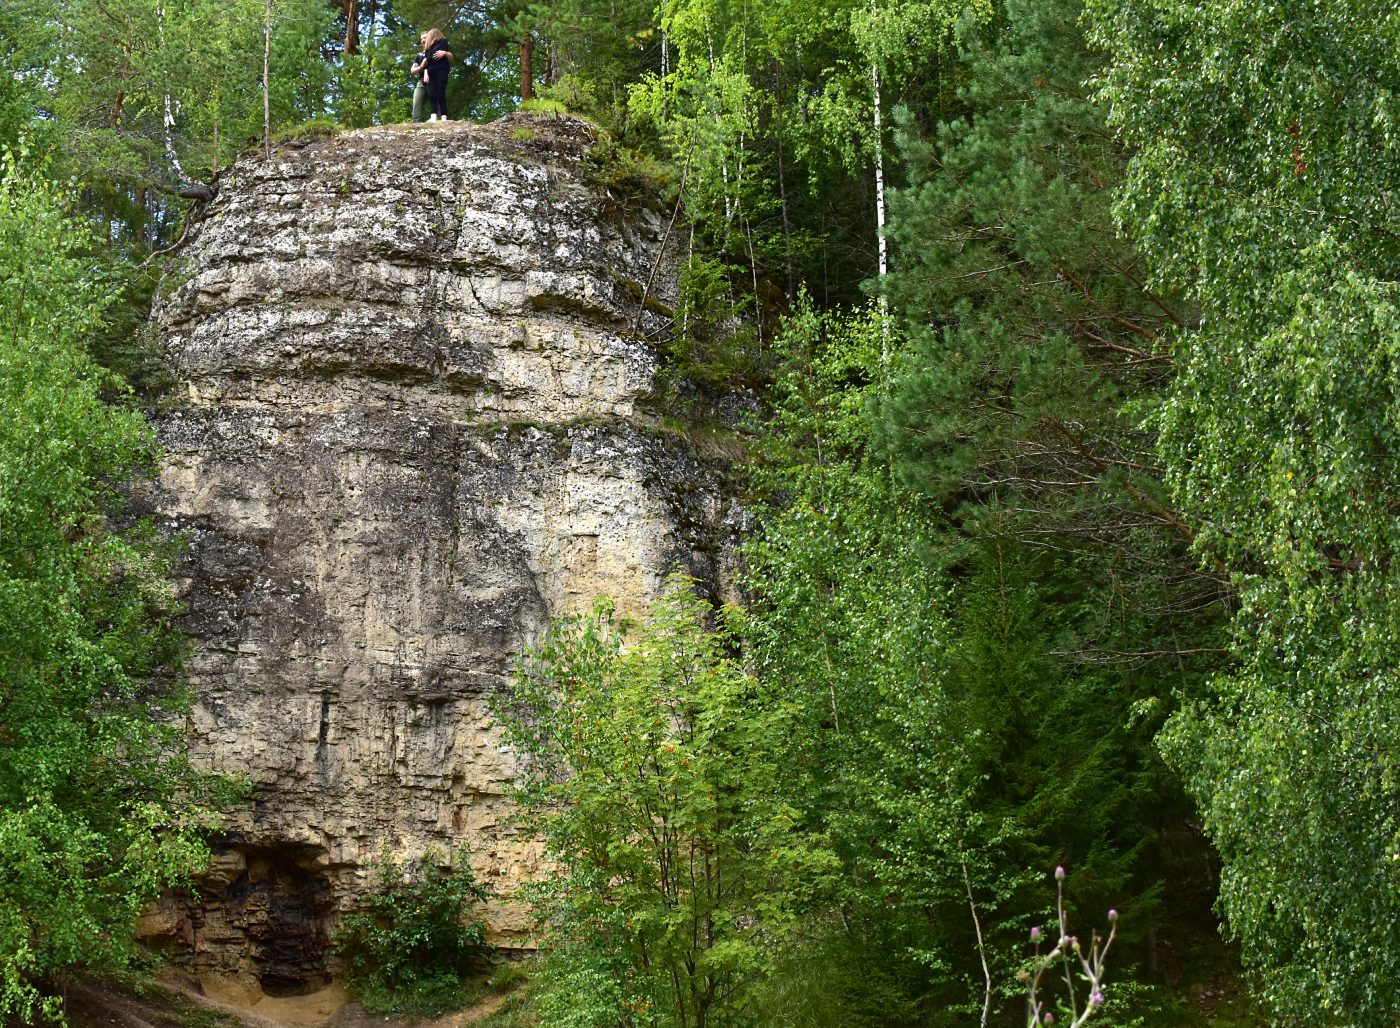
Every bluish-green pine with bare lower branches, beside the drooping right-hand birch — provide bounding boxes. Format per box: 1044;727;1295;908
876;0;1221;697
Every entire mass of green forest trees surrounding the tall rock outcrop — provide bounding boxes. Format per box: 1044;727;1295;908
0;0;1400;1025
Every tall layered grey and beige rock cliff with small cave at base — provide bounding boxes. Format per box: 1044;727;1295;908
151;118;735;994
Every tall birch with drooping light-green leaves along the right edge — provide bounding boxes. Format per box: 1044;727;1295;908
1092;0;1400;1025
